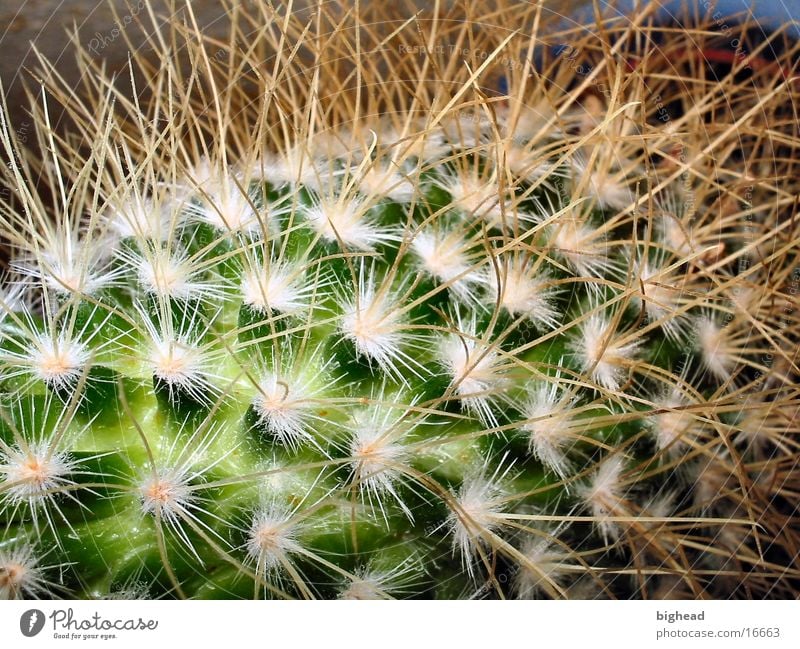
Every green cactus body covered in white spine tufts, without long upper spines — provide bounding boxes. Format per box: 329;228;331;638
0;0;795;597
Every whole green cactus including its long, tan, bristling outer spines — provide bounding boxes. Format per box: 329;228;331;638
0;3;800;599
